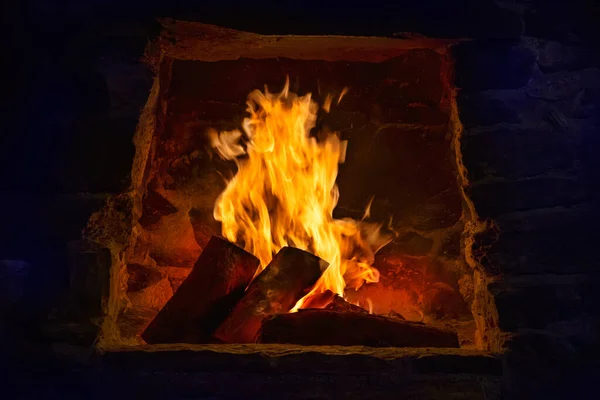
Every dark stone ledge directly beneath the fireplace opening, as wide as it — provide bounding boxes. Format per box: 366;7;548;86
99;345;502;399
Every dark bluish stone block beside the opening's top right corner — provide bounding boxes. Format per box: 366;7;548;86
455;41;535;90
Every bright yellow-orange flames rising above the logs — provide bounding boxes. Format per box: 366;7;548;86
209;80;391;309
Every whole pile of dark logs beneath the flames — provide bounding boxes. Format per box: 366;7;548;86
142;236;459;347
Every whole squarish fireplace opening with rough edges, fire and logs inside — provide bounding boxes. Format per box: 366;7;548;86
86;22;487;349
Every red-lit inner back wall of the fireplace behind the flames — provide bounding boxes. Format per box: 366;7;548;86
115;45;472;341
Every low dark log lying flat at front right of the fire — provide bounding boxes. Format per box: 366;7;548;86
260;309;459;347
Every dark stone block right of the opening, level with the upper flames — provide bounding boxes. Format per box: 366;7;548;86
462;127;575;181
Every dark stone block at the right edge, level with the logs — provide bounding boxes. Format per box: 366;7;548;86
488;275;600;331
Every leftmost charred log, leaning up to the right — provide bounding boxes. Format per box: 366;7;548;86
142;236;260;344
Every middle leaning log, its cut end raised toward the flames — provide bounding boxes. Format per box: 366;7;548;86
214;247;328;343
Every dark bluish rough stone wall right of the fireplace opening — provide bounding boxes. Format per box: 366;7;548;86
456;8;600;399
